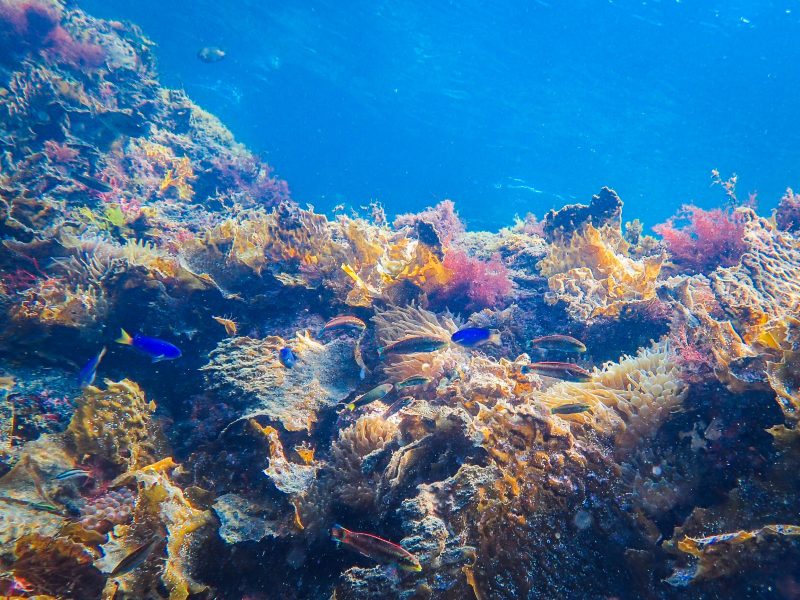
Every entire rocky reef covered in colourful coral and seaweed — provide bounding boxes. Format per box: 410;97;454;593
0;0;800;600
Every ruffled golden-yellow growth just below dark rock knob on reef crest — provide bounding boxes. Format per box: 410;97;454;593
539;224;663;321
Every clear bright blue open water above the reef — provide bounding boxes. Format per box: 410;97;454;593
78;0;800;228
